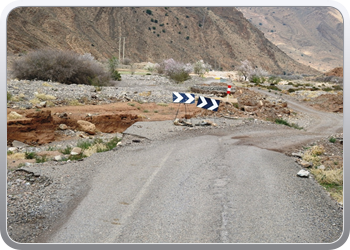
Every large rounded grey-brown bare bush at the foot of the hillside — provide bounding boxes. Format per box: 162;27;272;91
12;49;110;85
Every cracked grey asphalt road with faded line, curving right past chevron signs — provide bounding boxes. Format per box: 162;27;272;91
48;113;343;243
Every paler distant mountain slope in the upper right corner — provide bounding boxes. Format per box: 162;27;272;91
237;7;344;72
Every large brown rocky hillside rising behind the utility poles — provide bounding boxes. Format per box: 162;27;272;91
7;7;319;74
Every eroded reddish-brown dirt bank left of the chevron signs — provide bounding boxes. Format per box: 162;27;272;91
7;103;199;146
